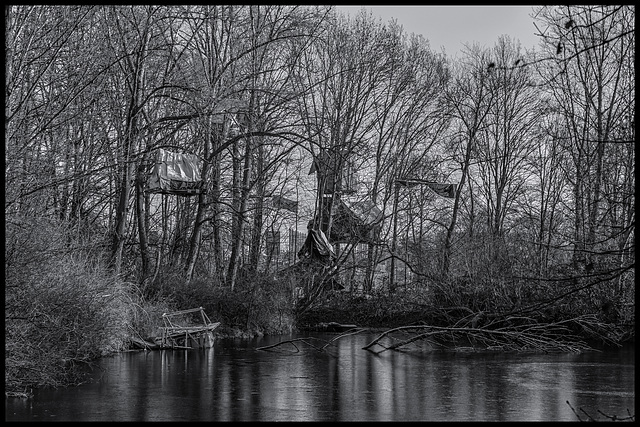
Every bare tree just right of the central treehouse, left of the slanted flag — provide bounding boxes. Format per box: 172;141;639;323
368;25;450;289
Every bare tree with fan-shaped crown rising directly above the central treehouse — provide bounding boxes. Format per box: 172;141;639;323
295;10;391;294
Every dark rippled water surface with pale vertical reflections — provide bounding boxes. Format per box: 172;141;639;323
5;334;635;421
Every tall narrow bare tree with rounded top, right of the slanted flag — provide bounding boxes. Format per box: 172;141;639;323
462;36;541;278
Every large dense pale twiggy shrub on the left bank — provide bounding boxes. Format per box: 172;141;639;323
5;218;131;392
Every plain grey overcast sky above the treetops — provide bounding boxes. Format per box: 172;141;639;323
336;5;539;57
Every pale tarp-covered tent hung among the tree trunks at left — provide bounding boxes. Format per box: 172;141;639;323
148;148;204;196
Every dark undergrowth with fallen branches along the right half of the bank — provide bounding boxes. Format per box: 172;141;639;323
298;281;635;346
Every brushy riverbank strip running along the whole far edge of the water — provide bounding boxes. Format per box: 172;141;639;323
5;268;635;402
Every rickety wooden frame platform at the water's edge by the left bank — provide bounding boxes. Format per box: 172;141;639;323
156;307;220;348
